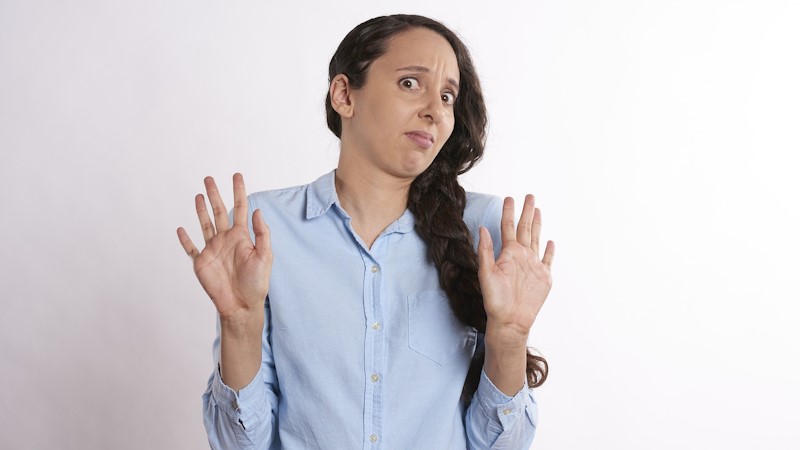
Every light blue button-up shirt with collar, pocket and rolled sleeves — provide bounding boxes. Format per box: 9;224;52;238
203;172;537;450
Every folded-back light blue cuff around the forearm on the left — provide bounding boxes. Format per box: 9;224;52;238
211;365;270;428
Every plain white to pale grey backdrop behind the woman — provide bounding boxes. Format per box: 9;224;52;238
0;0;800;450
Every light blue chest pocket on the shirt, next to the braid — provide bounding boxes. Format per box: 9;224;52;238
408;290;478;365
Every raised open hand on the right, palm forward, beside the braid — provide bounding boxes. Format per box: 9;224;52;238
478;194;555;342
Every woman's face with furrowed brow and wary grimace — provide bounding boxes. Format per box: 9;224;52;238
342;28;459;179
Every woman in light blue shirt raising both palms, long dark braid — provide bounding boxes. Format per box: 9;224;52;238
178;15;554;449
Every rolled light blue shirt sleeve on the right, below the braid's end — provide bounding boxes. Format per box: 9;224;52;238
466;370;538;450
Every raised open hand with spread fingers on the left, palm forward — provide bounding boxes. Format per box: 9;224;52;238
178;173;272;322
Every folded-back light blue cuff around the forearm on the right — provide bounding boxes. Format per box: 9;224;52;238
476;369;536;430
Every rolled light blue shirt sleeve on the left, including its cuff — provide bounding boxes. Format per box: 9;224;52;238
203;297;279;449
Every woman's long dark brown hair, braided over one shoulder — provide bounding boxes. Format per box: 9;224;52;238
325;15;548;402
